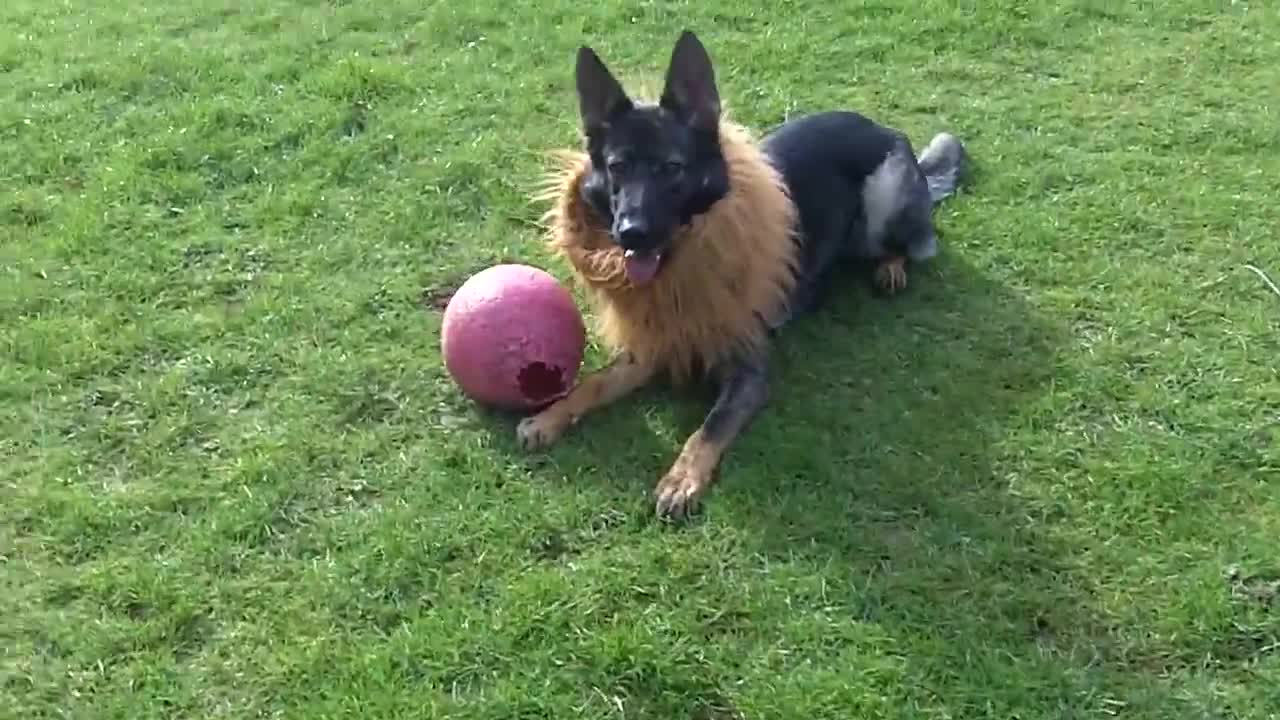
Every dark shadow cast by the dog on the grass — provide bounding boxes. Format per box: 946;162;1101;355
476;251;1136;714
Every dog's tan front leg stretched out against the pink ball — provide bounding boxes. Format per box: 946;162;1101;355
516;352;654;450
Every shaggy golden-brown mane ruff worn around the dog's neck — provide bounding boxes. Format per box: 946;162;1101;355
543;122;799;382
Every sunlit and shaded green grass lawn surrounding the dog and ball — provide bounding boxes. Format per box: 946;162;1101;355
0;0;1280;720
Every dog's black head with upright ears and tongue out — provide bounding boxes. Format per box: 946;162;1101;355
577;32;728;284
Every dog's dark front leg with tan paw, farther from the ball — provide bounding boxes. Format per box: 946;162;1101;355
654;356;769;519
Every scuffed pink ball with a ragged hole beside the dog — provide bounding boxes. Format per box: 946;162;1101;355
440;264;586;410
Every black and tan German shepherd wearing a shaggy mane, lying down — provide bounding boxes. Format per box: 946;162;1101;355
517;32;965;519
